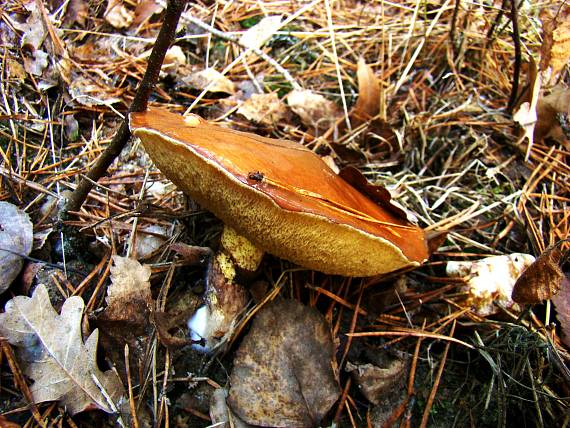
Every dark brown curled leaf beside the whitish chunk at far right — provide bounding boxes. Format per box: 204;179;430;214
513;243;565;304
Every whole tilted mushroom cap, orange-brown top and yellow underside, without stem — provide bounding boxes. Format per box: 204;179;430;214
130;109;428;276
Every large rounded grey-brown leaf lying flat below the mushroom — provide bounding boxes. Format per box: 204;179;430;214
228;300;339;427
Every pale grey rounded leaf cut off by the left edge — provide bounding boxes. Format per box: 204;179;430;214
0;201;34;293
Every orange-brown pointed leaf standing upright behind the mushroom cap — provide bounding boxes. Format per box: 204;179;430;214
351;58;380;127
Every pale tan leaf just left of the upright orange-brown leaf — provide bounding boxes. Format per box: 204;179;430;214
287;90;341;130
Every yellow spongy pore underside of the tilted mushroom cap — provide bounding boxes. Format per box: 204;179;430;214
134;129;419;276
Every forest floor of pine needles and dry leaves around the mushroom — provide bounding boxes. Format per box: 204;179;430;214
0;0;570;427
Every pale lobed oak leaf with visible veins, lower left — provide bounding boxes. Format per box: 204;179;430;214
0;285;124;415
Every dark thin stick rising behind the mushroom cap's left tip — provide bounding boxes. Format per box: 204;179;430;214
59;0;186;216
